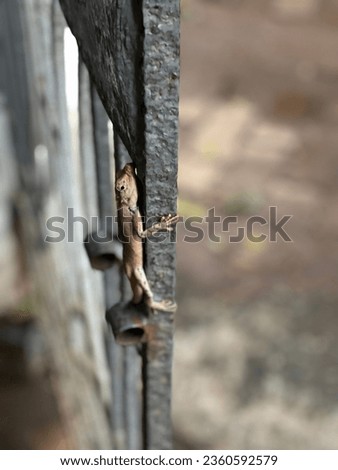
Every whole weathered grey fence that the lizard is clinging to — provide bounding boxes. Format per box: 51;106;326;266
0;0;179;449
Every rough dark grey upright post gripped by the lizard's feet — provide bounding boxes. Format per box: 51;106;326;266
143;0;180;449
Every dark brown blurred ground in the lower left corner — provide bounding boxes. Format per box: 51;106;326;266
0;310;70;450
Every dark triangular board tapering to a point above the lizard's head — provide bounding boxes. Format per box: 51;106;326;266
60;0;142;166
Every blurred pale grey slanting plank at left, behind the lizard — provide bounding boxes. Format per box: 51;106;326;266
2;0;111;449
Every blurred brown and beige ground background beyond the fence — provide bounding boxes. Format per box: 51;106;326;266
0;0;338;449
